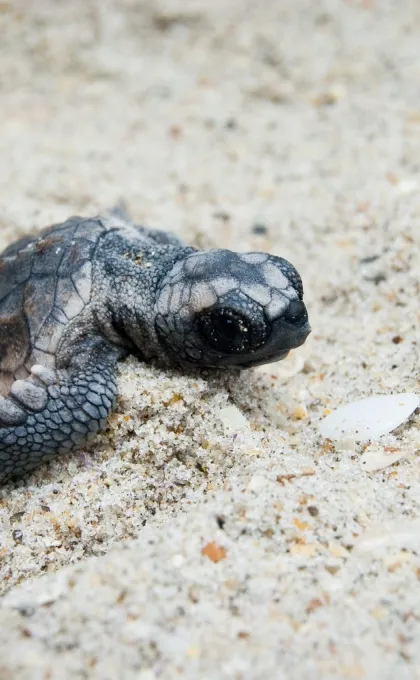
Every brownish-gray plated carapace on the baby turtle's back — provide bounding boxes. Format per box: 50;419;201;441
0;217;101;394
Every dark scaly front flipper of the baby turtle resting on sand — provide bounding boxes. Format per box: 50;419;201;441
0;338;120;483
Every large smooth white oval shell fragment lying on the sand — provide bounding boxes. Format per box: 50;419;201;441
319;393;420;441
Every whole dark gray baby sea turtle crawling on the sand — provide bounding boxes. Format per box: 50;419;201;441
0;210;310;482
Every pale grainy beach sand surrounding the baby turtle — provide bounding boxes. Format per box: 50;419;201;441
0;0;420;680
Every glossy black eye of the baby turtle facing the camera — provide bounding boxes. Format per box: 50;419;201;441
199;309;264;354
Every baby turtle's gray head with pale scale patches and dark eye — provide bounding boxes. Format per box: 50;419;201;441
155;250;310;368
